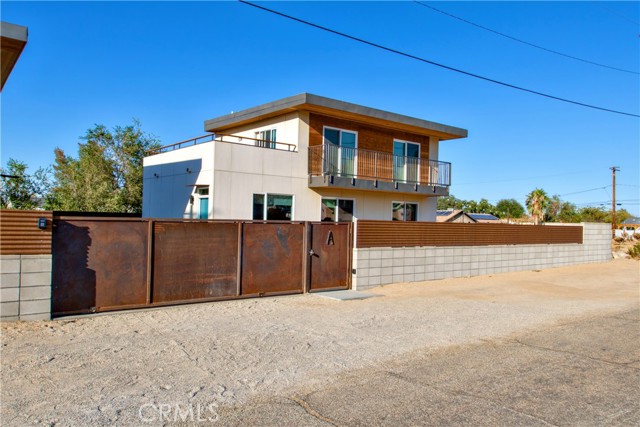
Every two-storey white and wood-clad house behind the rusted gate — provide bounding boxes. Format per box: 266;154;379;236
143;93;467;221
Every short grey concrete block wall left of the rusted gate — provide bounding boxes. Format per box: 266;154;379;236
0;255;51;322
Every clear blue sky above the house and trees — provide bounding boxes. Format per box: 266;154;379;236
0;1;640;215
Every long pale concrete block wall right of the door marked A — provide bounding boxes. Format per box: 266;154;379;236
352;223;611;290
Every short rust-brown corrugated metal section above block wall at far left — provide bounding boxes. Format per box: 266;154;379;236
0;209;52;255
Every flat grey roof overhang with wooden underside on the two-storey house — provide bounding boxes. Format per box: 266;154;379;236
204;93;468;140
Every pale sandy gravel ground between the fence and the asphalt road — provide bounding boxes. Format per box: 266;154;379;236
1;260;640;426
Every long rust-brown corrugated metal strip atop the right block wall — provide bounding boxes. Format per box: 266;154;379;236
356;220;582;248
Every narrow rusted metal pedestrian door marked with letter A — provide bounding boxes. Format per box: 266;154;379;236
309;222;352;292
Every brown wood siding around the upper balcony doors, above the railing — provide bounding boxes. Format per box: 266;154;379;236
309;113;429;159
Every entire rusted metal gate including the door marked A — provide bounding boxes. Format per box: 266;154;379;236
52;217;352;316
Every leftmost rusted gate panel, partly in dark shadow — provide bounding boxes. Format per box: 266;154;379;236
51;219;148;316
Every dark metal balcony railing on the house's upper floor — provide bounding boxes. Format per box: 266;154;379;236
309;144;451;187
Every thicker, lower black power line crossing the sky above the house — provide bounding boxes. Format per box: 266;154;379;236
238;0;640;117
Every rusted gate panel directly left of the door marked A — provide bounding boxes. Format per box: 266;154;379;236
241;223;305;295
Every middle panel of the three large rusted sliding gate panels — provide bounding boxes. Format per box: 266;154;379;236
151;222;239;303
